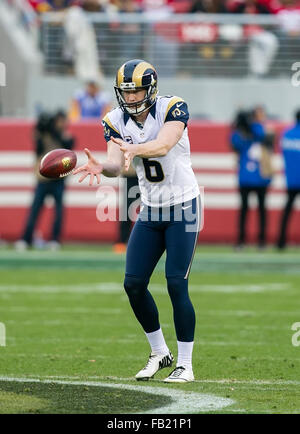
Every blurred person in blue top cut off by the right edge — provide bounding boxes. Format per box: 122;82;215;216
277;110;300;250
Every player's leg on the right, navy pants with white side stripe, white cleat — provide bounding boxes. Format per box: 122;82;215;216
165;196;201;382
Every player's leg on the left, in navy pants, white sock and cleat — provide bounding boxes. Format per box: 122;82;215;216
124;217;173;380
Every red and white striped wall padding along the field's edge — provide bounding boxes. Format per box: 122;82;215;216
0;119;300;243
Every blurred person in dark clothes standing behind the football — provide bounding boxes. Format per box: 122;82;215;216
15;111;74;250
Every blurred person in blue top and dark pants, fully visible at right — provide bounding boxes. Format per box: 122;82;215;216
230;111;271;249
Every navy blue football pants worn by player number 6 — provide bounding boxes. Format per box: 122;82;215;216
124;196;200;342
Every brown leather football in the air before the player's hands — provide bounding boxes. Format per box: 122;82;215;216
40;149;77;179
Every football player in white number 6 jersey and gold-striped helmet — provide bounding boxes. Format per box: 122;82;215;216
74;59;200;382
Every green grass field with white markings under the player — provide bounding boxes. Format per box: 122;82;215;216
0;245;300;414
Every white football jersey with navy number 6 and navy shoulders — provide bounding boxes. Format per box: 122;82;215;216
102;96;199;207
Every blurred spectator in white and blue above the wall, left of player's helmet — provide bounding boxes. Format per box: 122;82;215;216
69;80;112;121
